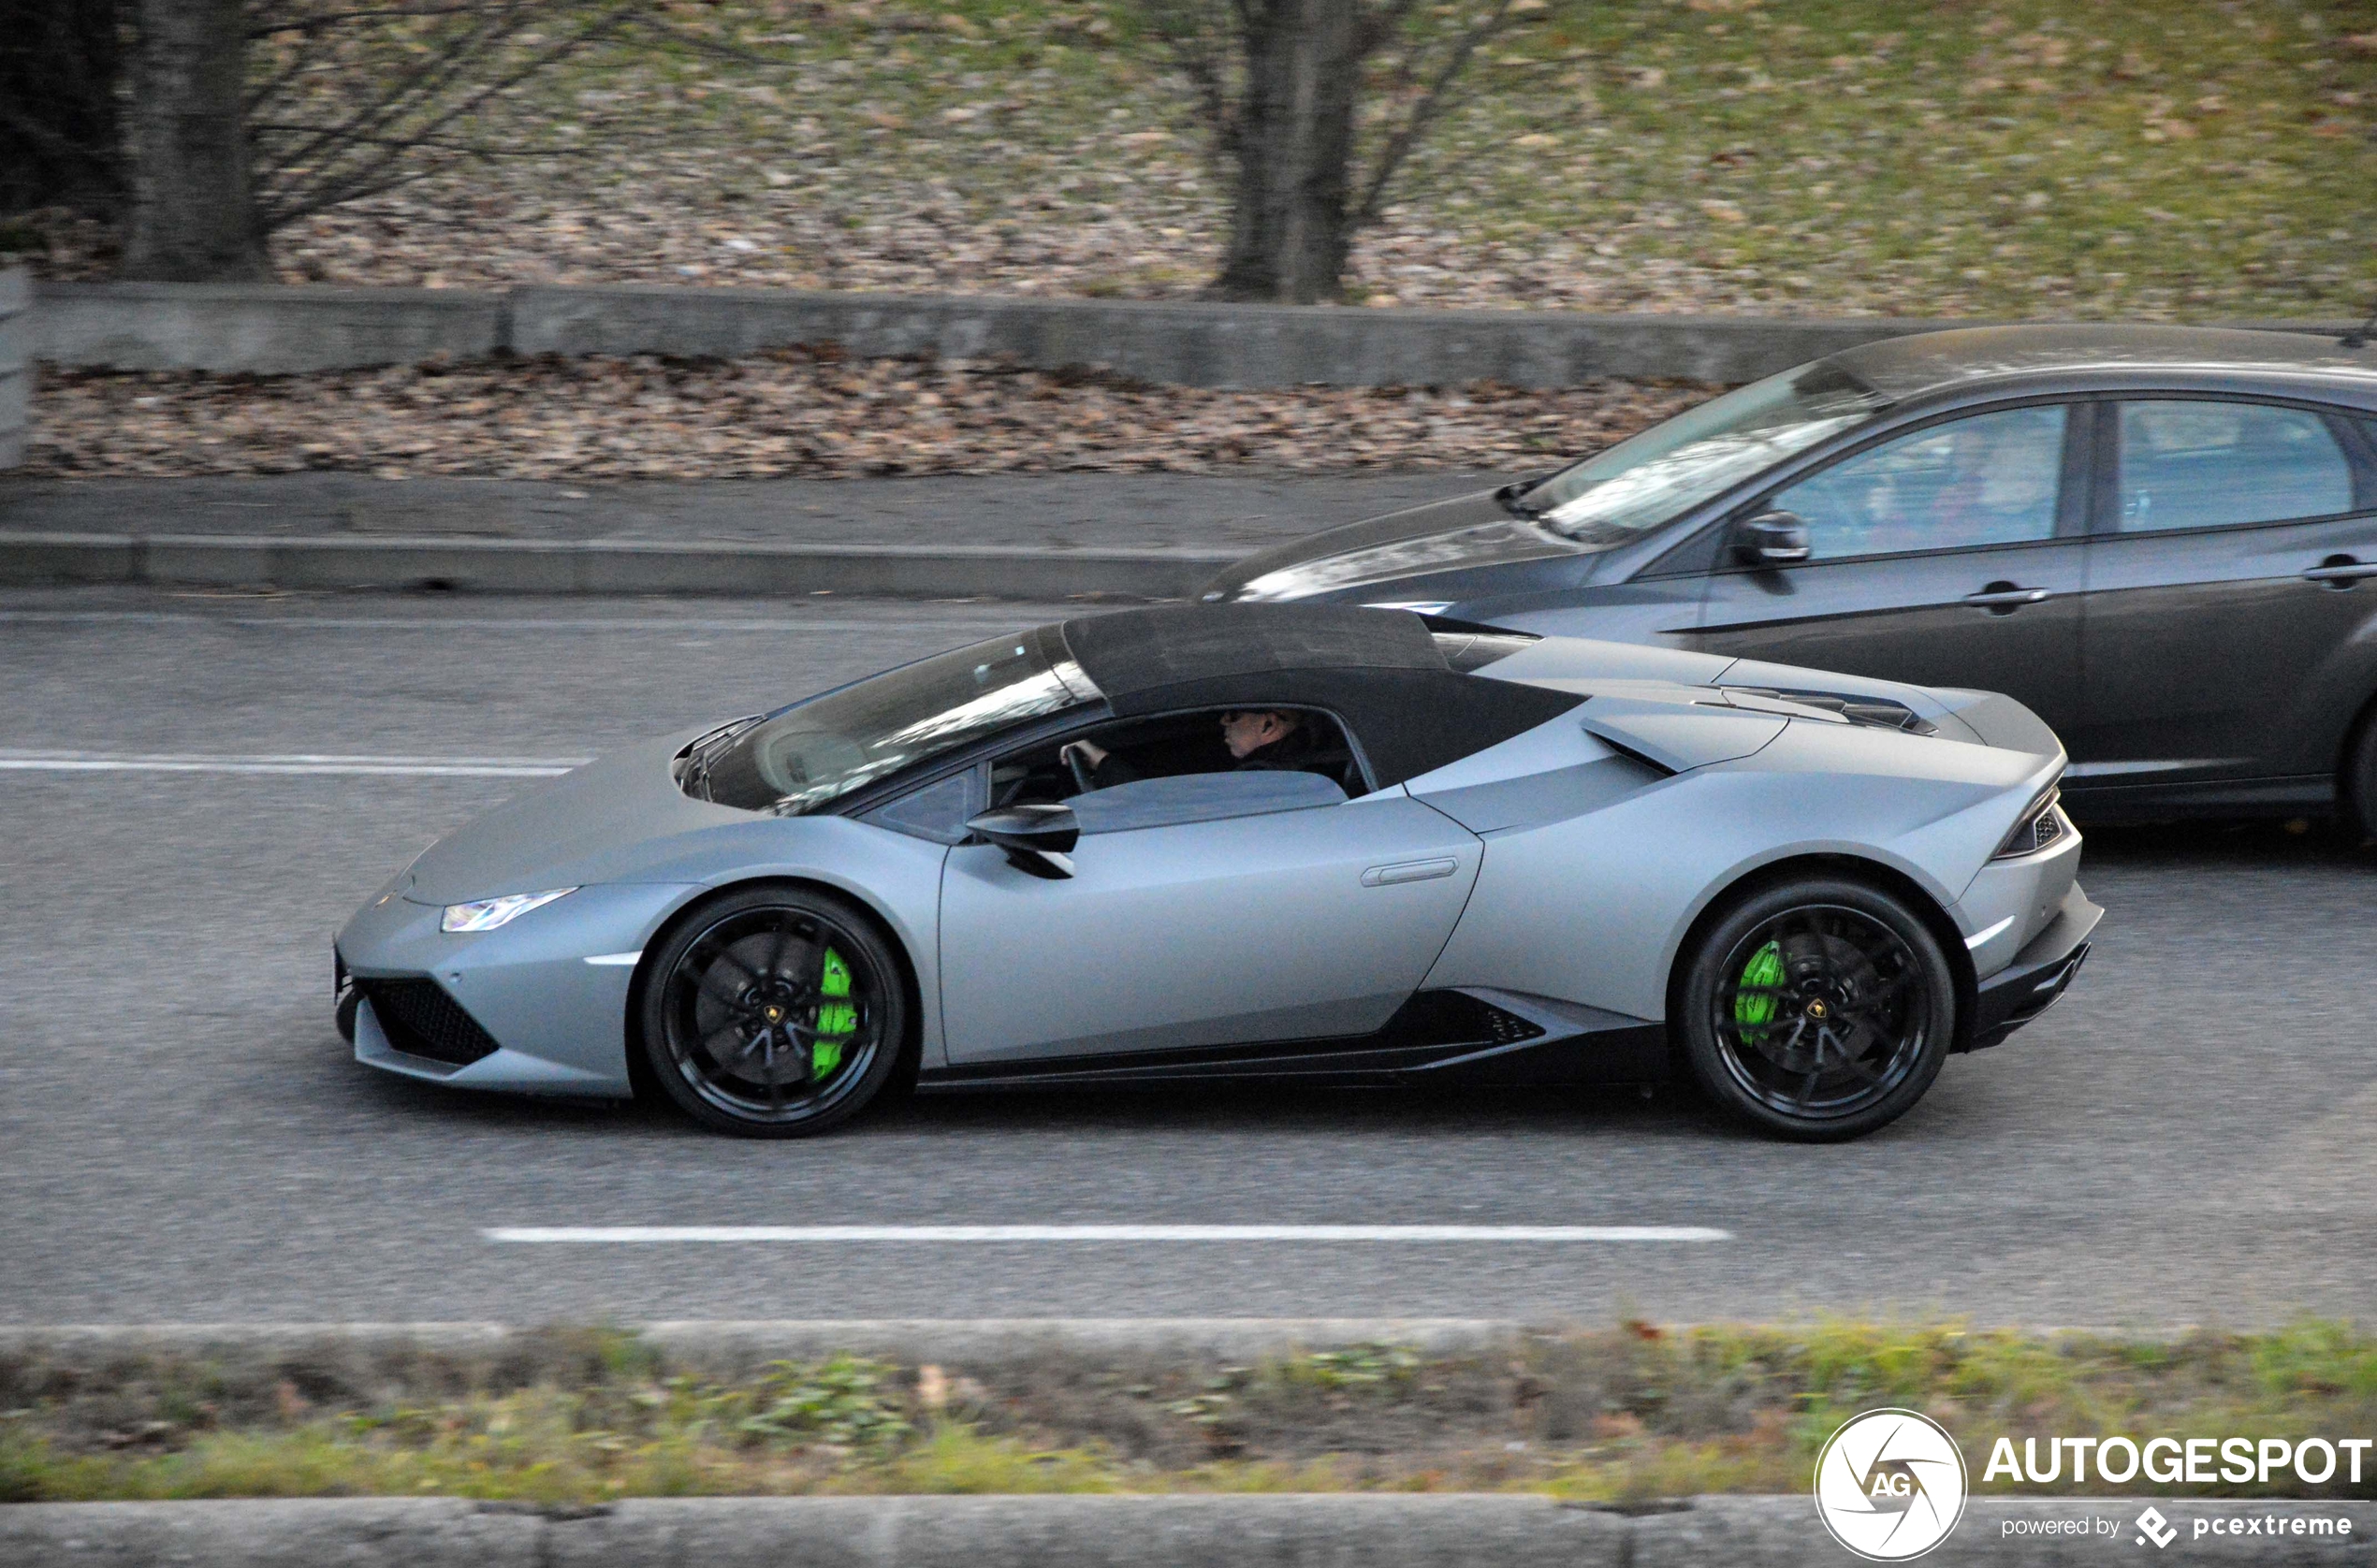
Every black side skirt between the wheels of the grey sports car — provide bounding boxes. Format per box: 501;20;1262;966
915;986;1669;1093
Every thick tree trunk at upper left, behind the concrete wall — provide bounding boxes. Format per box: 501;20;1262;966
124;0;271;283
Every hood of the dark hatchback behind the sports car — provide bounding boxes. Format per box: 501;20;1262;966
1205;489;1607;601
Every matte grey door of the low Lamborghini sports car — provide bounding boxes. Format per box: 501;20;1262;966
941;772;1480;1067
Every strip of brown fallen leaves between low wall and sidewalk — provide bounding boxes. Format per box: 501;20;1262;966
26;349;1713;480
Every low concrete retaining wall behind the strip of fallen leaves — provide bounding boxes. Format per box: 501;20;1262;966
22;283;2341;387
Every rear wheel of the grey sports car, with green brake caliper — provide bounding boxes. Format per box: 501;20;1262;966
1678;877;1956;1142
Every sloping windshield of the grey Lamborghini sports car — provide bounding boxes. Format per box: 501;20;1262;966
687;627;1098;818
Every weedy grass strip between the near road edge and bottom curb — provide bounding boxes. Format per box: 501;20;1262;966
0;1321;2377;1503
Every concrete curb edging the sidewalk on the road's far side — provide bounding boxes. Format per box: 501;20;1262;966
0;532;1238;601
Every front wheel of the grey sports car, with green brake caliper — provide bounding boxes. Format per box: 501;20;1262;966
639;886;908;1138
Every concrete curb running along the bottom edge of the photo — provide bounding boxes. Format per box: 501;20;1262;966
0;1492;2377;1568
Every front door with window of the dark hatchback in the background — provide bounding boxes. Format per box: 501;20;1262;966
1692;401;2087;730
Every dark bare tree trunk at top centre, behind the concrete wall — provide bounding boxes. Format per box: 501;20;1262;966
1215;0;1364;304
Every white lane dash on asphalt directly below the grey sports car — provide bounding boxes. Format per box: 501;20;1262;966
480;1226;1733;1242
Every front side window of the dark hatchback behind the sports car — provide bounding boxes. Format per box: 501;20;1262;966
1769;404;2068;560
